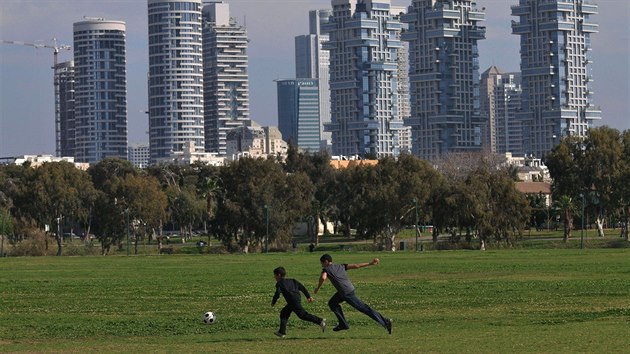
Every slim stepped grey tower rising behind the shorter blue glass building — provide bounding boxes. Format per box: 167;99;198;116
295;9;332;148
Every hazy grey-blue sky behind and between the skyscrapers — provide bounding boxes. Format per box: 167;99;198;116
0;0;630;157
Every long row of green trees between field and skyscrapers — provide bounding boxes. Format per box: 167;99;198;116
0;127;630;255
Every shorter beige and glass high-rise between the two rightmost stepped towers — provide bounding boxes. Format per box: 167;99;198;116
479;65;524;156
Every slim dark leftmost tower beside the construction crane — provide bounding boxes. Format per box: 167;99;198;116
55;60;75;157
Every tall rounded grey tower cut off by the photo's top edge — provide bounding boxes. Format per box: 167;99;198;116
148;0;204;163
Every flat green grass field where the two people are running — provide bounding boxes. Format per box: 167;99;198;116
0;248;630;353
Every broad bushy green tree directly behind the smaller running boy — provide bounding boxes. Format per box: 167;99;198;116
213;158;314;253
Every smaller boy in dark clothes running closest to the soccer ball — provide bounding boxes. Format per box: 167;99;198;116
271;267;326;338
